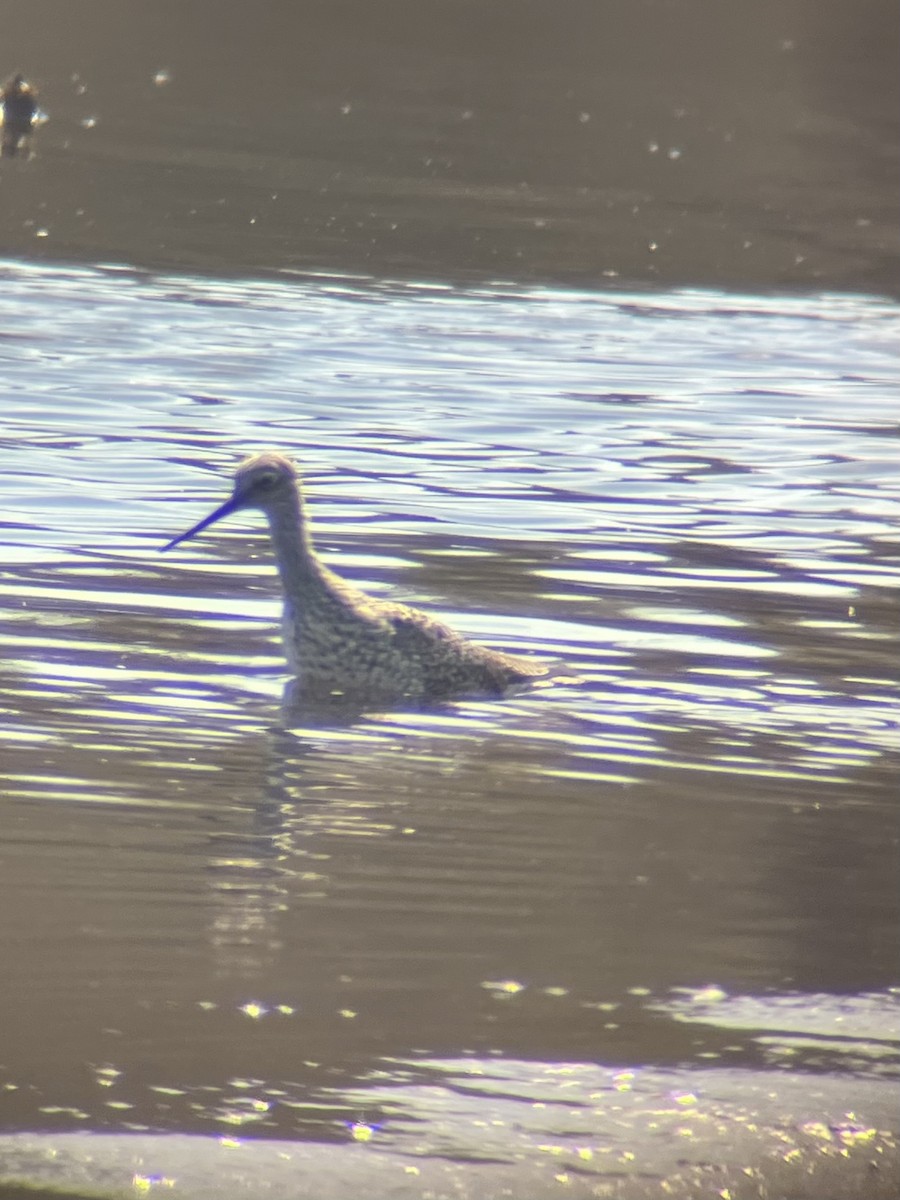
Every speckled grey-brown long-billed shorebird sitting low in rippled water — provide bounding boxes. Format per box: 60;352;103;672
162;451;548;700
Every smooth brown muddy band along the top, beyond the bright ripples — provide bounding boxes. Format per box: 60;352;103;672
0;0;900;295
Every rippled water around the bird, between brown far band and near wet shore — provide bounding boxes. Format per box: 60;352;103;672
0;264;900;1190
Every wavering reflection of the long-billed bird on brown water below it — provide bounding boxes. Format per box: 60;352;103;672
198;679;542;982
